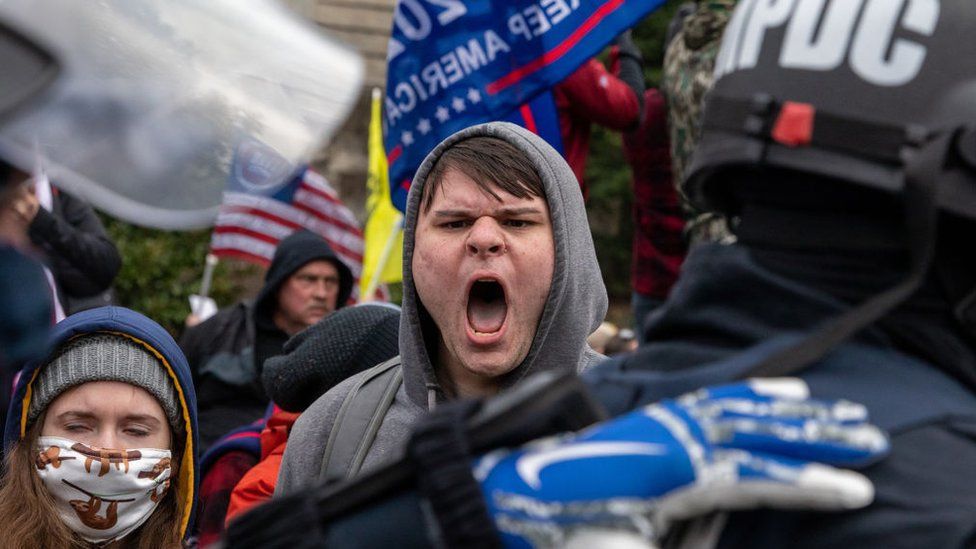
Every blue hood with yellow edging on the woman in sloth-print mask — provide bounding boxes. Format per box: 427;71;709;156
4;307;198;536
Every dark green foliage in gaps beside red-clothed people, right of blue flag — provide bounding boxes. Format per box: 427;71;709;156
586;2;680;308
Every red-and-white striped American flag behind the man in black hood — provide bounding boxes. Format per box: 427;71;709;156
210;164;386;299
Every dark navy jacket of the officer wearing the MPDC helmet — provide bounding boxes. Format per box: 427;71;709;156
585;245;976;549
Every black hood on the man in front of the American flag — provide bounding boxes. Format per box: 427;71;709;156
254;229;353;316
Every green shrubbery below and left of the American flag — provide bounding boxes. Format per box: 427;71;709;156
102;216;262;336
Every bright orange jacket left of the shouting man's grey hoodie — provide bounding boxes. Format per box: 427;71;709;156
224;406;299;524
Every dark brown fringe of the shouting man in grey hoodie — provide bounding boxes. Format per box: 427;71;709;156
420;136;546;212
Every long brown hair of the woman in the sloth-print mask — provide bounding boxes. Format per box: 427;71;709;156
0;417;189;549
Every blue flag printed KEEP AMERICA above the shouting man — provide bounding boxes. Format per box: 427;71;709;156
384;0;664;211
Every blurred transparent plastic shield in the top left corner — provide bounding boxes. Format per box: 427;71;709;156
0;0;362;229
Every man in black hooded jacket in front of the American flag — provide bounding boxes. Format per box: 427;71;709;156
180;230;353;448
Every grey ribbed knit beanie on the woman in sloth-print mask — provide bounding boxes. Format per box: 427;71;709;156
27;333;183;431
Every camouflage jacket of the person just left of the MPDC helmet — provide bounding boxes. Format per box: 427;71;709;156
662;0;736;244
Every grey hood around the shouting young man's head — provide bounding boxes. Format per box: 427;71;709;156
400;122;607;408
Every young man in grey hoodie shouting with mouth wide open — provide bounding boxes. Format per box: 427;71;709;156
277;123;607;494
